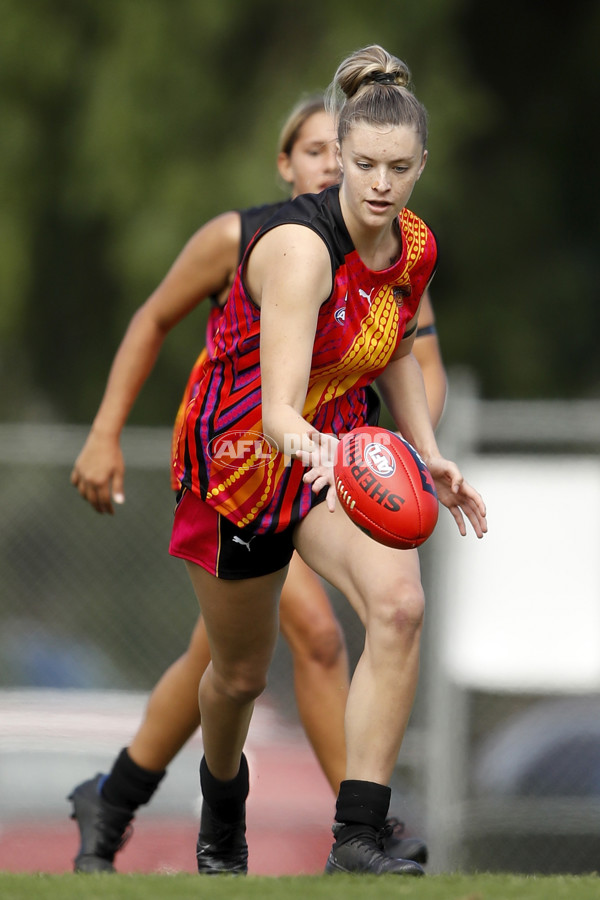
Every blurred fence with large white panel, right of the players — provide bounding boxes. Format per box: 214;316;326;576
421;373;600;873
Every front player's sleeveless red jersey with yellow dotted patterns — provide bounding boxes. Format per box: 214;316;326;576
176;187;437;533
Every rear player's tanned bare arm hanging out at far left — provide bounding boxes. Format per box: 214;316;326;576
71;212;241;513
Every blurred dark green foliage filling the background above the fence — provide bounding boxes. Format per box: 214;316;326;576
0;0;600;423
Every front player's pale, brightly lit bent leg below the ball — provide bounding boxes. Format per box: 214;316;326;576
296;504;423;785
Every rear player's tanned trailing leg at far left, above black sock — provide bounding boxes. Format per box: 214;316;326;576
127;617;210;772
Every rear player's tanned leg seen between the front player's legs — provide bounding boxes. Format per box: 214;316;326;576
280;553;350;794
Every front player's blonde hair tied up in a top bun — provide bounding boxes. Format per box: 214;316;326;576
326;44;427;147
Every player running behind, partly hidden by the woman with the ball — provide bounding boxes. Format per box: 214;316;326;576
71;89;446;872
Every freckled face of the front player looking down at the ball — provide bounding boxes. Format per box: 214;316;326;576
339;122;427;228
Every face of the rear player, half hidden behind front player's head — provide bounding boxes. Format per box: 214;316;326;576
277;110;340;197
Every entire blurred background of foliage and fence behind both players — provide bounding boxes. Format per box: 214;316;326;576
0;0;600;874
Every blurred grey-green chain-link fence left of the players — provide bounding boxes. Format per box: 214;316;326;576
0;425;362;719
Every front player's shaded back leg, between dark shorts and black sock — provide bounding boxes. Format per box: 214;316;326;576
186;562;286;781
